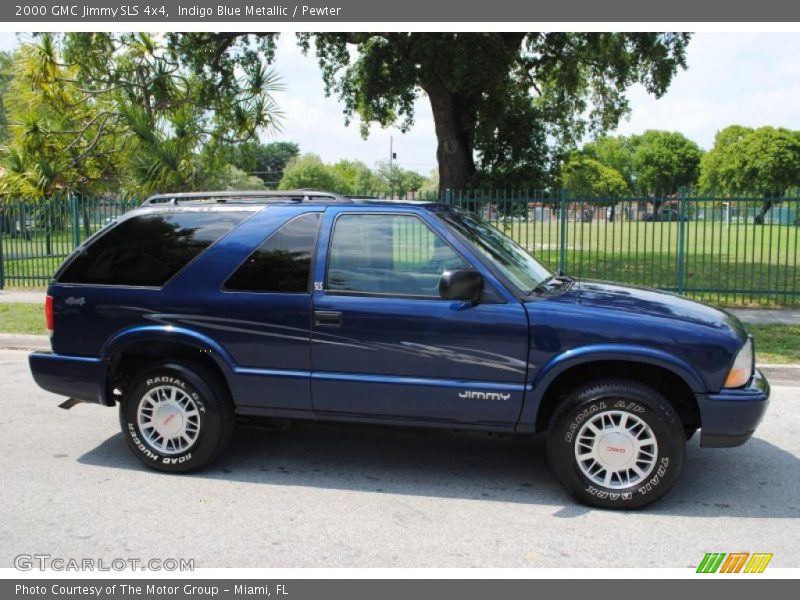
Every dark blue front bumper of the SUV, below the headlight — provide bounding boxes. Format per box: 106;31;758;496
697;369;769;448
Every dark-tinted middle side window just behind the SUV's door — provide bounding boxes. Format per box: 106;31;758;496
225;213;321;292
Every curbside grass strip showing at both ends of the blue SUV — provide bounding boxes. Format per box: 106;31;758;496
0;303;800;364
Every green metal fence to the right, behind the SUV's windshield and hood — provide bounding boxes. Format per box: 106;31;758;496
446;192;800;306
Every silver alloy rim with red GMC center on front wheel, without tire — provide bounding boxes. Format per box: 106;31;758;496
575;410;658;489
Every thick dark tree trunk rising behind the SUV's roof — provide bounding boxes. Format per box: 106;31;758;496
424;83;475;190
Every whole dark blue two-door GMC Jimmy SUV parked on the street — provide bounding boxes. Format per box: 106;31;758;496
30;191;769;508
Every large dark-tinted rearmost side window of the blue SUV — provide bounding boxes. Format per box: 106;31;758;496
59;211;250;287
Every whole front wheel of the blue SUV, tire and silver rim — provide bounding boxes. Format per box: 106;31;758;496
547;379;686;509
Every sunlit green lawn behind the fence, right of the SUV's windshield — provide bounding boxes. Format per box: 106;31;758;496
496;221;800;306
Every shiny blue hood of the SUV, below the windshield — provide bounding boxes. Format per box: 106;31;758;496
559;281;747;341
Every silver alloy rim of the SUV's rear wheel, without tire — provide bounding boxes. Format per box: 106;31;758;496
136;385;200;454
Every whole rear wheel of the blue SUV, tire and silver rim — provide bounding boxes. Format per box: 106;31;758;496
119;362;234;473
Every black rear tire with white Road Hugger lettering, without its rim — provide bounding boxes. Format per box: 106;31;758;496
119;365;227;472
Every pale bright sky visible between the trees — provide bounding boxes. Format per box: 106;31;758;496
0;33;800;175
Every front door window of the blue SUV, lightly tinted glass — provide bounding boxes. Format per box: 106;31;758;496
327;214;468;298
